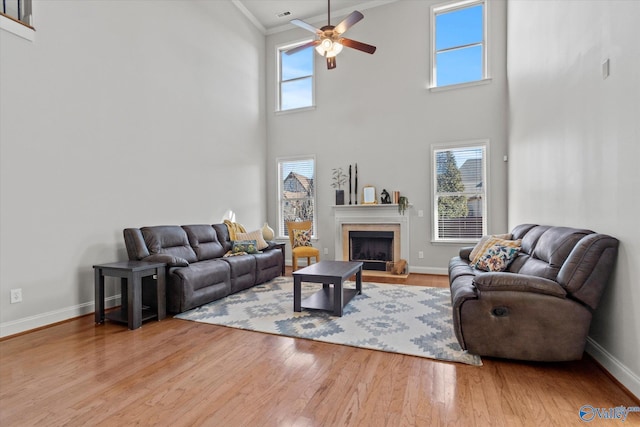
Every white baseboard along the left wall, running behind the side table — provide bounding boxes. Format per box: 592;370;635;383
0;295;120;338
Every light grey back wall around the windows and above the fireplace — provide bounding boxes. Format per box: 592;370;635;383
266;1;507;274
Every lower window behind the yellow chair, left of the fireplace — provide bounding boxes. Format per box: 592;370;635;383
278;156;316;237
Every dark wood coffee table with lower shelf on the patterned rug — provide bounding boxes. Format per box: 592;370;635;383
292;261;362;316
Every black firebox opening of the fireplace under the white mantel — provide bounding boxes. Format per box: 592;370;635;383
349;231;394;271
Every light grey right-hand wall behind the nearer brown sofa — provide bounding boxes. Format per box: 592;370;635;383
508;0;640;396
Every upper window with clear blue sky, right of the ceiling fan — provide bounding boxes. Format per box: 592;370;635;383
431;0;488;87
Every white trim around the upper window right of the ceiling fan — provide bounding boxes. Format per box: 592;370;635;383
428;0;491;92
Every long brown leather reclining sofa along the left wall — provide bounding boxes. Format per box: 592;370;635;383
123;224;284;313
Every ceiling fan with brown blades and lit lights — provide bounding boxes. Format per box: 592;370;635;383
285;0;376;70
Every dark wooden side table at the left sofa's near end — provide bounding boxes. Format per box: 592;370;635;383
93;261;167;329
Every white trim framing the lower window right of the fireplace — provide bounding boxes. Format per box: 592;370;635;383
430;138;491;245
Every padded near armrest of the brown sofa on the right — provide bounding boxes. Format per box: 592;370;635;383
473;272;567;298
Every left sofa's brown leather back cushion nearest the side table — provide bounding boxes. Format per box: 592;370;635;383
140;225;198;262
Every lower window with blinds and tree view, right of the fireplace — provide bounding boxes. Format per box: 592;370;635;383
431;141;487;241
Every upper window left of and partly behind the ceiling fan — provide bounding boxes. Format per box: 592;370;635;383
277;40;314;111
